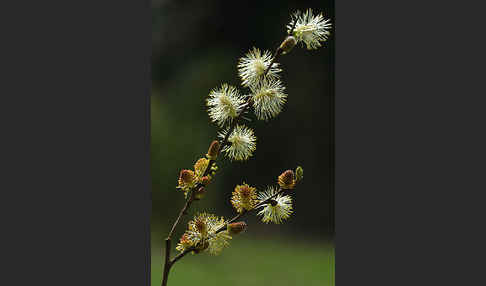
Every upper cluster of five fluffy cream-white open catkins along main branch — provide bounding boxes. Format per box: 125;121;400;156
206;9;331;161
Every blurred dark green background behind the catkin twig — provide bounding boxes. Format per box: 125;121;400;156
151;0;335;286
